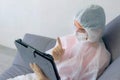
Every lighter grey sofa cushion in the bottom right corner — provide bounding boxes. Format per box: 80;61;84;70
98;57;120;80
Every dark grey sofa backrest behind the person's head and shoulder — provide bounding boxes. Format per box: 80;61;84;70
103;15;120;61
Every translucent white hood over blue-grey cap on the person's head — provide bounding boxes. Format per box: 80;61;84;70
74;5;105;42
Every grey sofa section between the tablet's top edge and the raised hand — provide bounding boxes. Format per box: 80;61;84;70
23;33;56;52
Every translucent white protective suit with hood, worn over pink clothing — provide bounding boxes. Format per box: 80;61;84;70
7;5;110;80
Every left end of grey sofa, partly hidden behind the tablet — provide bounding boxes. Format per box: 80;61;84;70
0;34;56;80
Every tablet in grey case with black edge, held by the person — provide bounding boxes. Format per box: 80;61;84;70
15;39;60;80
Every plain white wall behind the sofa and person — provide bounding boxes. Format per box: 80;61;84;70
0;0;120;48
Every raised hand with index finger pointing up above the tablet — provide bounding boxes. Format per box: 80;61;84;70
52;37;65;61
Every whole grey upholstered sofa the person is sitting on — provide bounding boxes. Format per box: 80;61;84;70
0;15;120;80
